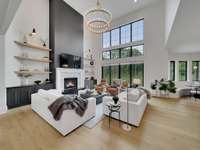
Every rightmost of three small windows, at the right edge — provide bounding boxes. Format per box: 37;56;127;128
192;61;200;81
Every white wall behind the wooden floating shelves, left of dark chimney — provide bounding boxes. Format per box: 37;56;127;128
5;0;49;87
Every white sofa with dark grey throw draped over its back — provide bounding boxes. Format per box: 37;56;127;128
31;90;96;136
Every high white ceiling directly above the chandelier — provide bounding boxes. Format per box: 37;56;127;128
64;0;159;19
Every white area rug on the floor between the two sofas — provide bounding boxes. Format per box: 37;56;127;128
84;104;104;129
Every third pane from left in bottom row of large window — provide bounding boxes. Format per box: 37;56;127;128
120;65;130;83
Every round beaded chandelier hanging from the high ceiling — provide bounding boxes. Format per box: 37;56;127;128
85;0;112;33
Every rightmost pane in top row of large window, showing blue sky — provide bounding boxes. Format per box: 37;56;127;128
132;20;144;42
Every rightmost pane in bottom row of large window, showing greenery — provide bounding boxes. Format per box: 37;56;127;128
132;64;144;85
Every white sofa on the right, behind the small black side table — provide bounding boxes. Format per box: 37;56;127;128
103;92;148;127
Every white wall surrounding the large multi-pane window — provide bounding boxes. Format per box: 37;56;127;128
85;1;168;88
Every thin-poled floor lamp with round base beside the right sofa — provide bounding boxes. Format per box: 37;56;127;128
122;82;132;132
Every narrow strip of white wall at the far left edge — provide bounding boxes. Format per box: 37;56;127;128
0;35;7;114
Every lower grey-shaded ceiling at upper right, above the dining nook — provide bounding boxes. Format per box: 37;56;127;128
167;0;200;52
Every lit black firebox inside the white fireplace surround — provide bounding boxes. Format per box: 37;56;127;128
64;78;78;94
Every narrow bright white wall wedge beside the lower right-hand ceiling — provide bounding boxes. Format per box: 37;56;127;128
165;0;181;43
